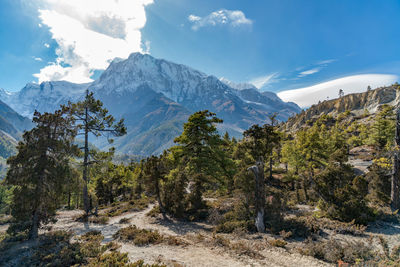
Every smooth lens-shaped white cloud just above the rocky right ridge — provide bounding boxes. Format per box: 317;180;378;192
278;74;400;108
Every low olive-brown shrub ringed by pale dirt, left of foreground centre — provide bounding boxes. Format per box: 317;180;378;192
114;225;163;246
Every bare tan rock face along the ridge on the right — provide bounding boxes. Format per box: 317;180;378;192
285;84;400;131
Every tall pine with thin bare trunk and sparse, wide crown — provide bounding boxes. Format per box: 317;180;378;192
63;90;126;215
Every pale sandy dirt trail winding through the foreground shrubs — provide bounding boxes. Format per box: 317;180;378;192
52;204;330;267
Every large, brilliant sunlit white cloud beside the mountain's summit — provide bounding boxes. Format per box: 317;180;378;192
34;0;153;83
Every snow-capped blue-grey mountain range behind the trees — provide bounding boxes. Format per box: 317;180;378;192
0;53;300;155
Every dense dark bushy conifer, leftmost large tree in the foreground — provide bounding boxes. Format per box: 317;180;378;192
5;111;78;239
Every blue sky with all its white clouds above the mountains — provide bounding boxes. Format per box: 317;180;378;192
0;0;400;107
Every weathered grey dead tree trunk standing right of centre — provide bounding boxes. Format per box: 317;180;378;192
248;158;265;233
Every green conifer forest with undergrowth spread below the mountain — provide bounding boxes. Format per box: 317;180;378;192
0;88;400;266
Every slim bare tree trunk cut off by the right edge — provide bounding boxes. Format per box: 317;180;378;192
390;108;400;210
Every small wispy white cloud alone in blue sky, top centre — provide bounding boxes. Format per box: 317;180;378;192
188;9;253;31
